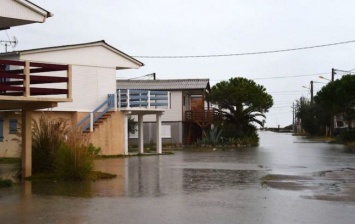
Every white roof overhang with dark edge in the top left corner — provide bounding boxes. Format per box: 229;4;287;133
0;0;53;30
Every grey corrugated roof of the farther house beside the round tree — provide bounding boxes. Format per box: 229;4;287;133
116;79;210;90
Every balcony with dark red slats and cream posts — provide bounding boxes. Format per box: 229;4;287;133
0;60;72;110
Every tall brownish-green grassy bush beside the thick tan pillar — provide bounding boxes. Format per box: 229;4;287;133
23;114;101;180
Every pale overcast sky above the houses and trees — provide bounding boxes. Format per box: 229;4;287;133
0;0;355;127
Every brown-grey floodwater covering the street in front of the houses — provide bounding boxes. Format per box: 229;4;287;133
0;132;355;224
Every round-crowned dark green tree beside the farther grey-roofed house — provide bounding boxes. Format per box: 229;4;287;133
207;77;273;135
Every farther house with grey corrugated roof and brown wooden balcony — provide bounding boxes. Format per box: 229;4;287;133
116;79;214;145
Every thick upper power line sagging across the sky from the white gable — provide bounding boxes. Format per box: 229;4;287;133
133;40;355;59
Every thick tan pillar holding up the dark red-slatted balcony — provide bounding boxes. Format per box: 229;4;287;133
22;110;32;178
